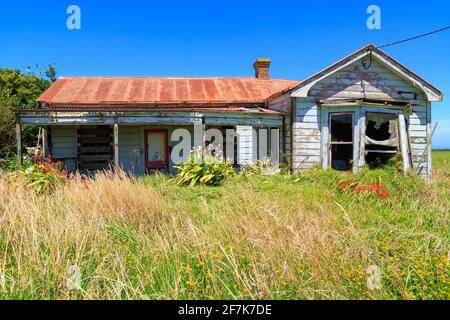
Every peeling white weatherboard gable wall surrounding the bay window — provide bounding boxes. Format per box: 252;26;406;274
292;60;431;178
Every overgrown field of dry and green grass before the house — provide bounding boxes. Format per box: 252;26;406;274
0;151;450;299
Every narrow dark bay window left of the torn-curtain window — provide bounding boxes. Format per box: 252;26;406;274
330;113;353;171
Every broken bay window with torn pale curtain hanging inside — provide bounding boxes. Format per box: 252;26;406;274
365;112;399;168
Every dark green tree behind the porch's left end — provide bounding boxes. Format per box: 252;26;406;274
0;65;56;158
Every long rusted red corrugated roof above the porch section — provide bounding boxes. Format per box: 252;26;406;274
38;77;300;105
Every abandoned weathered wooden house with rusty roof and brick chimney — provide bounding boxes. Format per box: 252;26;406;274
17;45;443;179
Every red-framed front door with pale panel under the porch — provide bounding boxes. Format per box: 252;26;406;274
144;129;169;174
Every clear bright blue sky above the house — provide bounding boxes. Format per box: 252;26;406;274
0;0;450;148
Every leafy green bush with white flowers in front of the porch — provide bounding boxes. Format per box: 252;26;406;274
175;150;236;186
